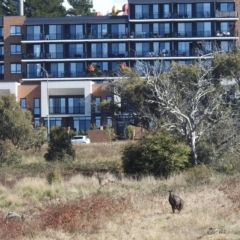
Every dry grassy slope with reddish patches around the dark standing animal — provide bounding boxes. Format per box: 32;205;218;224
0;142;240;240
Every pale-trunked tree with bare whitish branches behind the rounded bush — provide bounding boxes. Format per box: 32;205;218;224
112;59;234;165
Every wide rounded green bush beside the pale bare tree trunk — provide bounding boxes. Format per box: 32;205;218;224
122;132;190;177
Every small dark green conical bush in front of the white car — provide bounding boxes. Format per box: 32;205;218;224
44;126;75;161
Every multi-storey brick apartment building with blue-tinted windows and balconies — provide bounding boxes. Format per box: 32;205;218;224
0;0;239;133
